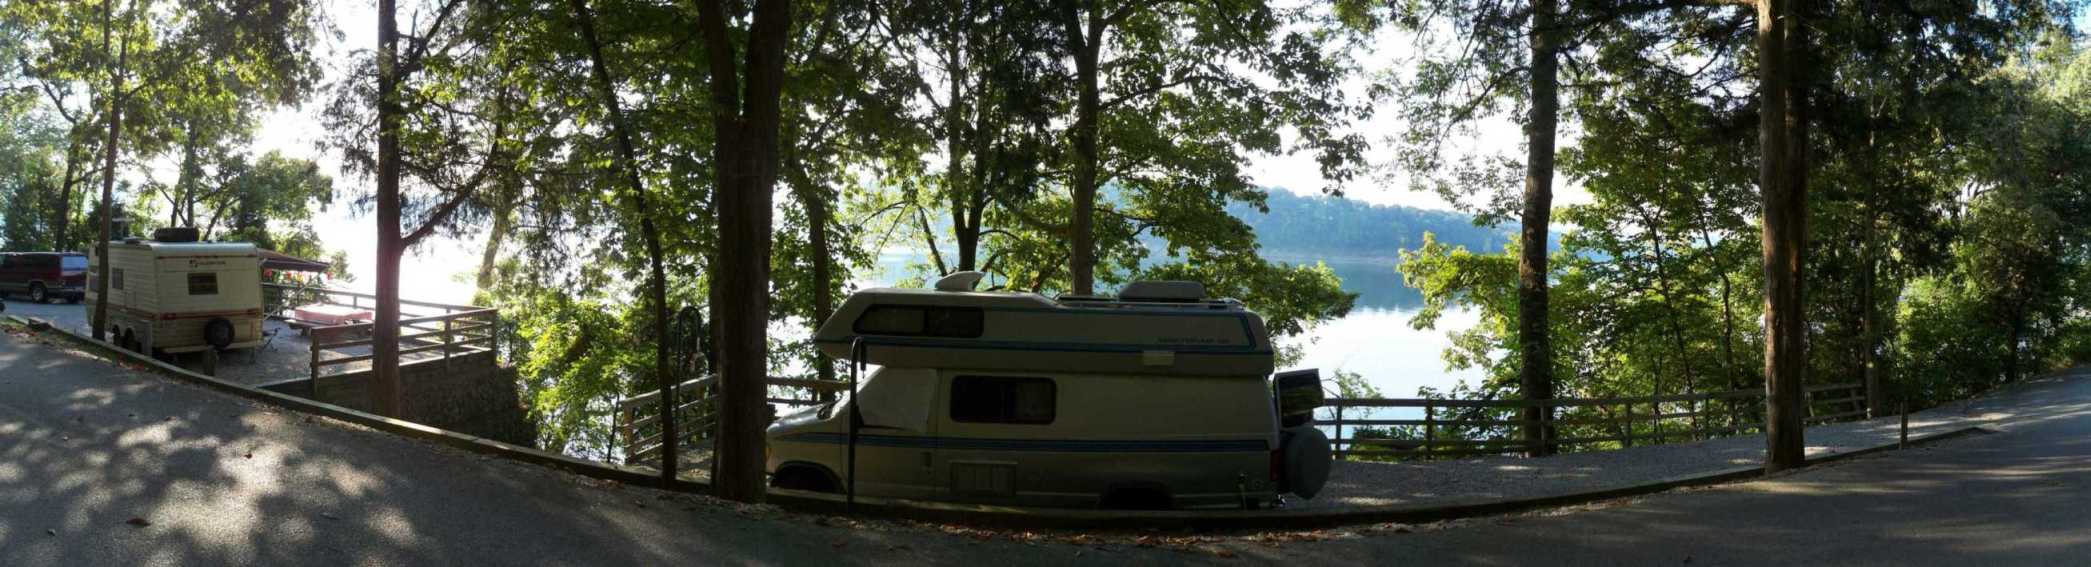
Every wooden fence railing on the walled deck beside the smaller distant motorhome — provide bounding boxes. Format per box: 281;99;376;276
261;285;502;379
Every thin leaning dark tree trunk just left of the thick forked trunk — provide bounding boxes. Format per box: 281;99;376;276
571;0;682;487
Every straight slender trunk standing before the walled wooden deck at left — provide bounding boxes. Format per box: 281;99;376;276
370;0;406;416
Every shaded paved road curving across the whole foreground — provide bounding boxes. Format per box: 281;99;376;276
0;324;2091;567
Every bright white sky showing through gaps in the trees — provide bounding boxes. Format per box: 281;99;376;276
251;0;1589;303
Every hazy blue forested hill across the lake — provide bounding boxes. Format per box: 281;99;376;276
1227;188;1516;257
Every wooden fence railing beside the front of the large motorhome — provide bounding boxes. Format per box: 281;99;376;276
617;377;849;462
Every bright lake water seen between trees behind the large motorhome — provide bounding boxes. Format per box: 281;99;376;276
859;253;1480;398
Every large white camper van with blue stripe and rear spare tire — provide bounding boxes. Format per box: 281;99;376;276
767;272;1330;508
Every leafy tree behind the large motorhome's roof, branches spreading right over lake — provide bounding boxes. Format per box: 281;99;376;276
1039;0;1370;295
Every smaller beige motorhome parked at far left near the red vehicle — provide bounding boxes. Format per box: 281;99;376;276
88;232;261;354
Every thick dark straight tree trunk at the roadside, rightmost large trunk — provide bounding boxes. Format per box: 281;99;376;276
1756;0;1809;473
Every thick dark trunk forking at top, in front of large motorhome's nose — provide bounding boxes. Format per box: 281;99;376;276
698;0;790;502
